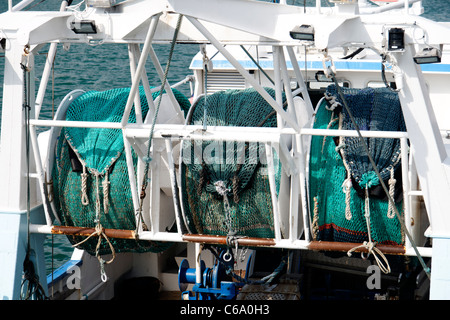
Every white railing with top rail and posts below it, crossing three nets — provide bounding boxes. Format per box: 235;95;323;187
30;114;431;257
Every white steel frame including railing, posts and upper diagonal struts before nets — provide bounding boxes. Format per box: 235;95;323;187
19;5;431;256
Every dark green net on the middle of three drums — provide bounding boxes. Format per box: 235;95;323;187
181;88;284;238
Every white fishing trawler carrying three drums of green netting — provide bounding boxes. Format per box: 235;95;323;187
0;0;450;300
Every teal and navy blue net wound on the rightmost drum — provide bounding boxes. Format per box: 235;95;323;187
309;85;405;245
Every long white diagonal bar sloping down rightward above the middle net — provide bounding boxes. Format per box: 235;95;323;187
186;16;299;130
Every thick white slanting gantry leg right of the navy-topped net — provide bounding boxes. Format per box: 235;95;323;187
394;45;450;238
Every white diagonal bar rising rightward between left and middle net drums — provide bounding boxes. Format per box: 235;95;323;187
121;14;160;127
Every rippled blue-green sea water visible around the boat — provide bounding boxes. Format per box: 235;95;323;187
0;0;450;274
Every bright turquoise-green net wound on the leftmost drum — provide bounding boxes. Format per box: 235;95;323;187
52;87;190;255
